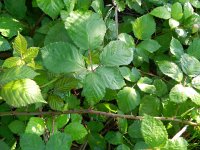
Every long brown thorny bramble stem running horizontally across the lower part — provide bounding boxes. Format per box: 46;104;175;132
0;109;200;126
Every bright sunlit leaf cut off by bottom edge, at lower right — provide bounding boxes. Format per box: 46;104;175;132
164;137;188;150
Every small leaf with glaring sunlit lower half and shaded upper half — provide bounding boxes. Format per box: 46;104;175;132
137;77;156;94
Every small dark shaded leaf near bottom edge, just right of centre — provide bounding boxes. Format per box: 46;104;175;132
105;131;123;145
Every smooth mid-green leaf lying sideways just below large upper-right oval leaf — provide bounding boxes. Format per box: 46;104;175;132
137;39;160;53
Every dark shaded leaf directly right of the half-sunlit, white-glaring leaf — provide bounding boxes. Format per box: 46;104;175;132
153;79;168;97
